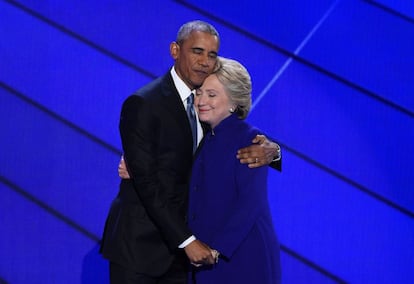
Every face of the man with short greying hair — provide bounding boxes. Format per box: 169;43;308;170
170;31;219;89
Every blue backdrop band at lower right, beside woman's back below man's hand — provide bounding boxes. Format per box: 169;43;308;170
269;151;414;284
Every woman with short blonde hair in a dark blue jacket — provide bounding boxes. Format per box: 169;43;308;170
188;58;280;284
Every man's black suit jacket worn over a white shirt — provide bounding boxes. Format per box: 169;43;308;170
101;72;193;276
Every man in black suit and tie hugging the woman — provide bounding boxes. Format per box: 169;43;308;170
101;21;280;283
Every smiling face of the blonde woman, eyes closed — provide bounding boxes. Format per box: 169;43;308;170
194;74;234;128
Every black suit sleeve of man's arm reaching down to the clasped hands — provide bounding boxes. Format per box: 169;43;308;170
119;95;191;249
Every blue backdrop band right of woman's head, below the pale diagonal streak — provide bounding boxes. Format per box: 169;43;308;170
250;60;414;212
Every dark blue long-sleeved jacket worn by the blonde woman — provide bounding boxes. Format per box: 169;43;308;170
188;114;280;284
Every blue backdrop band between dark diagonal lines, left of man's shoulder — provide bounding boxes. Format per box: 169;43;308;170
0;2;149;148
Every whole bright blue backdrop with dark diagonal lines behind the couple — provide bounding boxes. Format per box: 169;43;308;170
0;0;414;284
